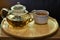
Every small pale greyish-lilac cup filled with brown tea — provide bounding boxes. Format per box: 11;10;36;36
33;10;49;24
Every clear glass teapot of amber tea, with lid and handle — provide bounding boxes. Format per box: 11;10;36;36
1;2;32;27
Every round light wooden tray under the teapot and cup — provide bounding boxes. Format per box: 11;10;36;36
1;17;58;38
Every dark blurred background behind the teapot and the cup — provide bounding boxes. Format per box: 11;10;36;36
0;0;60;24
